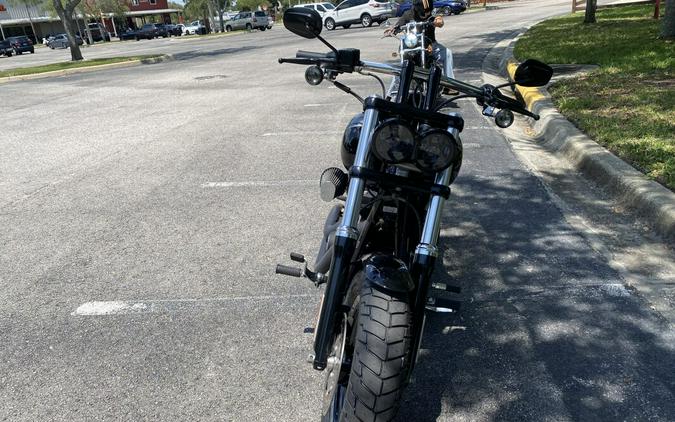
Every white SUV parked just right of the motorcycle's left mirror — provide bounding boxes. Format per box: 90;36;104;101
323;0;396;30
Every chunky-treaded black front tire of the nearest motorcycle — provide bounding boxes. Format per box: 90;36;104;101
341;286;412;422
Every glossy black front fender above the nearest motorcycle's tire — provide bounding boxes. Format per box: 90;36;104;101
363;254;415;293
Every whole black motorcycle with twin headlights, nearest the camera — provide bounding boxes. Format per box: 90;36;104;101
276;8;552;421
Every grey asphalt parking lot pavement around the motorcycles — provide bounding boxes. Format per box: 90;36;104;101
0;0;675;421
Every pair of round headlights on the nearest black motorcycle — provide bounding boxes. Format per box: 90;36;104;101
373;118;460;172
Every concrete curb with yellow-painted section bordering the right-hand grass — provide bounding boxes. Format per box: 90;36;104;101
483;33;675;240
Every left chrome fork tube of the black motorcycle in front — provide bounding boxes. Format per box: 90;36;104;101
335;104;378;239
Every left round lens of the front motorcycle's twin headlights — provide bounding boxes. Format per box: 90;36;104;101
373;118;415;164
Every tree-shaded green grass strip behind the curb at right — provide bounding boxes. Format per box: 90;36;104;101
515;5;675;190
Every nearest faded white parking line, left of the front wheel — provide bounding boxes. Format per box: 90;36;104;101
71;294;318;316
